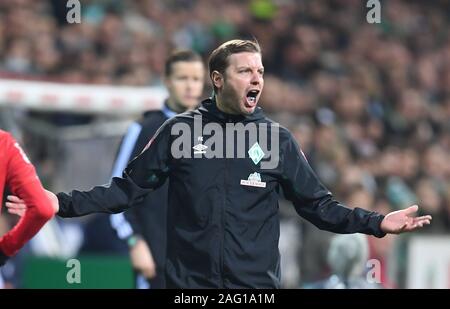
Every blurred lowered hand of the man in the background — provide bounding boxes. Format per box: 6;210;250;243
130;238;156;279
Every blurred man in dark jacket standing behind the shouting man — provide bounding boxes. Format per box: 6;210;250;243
110;50;205;289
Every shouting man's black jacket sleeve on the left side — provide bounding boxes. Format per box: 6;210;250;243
57;121;171;217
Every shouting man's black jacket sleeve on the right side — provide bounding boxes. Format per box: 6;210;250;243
280;130;386;237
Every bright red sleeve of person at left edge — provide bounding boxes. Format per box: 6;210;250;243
0;137;54;256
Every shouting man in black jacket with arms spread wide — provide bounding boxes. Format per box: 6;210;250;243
6;40;431;288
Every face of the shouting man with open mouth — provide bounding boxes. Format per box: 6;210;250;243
216;52;264;115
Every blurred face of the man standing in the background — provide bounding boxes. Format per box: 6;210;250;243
165;61;205;112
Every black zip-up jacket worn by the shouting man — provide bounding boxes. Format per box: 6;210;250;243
58;99;385;288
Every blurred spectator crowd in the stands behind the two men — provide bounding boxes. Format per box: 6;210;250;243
0;0;450;287
